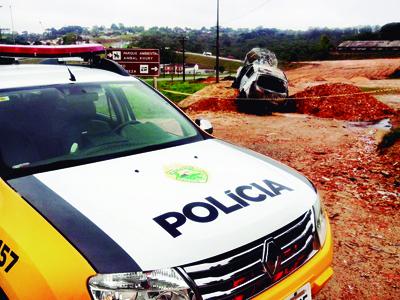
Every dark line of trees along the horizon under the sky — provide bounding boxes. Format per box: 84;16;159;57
0;23;400;62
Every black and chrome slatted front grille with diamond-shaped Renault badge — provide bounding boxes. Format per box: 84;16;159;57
180;211;319;300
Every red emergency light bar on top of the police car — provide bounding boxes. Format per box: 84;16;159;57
0;44;105;58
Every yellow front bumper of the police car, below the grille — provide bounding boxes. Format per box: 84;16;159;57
254;218;333;300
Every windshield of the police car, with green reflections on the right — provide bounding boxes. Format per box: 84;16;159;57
0;81;203;176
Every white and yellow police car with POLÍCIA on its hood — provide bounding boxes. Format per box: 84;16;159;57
0;45;333;300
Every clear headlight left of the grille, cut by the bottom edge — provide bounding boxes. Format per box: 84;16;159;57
88;269;194;300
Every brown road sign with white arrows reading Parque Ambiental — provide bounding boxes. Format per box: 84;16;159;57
107;48;160;77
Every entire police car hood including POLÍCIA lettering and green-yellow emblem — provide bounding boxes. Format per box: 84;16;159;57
11;139;317;272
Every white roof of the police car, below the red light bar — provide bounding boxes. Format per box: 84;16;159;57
0;64;137;90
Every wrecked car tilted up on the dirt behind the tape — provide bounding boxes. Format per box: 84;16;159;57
232;48;288;113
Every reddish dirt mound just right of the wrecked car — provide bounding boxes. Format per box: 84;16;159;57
293;83;395;121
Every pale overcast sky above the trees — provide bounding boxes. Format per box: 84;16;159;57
0;0;400;32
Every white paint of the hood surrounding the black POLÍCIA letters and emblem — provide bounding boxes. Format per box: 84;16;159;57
35;139;317;270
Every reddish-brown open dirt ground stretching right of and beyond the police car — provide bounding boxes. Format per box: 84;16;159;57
182;59;400;299
